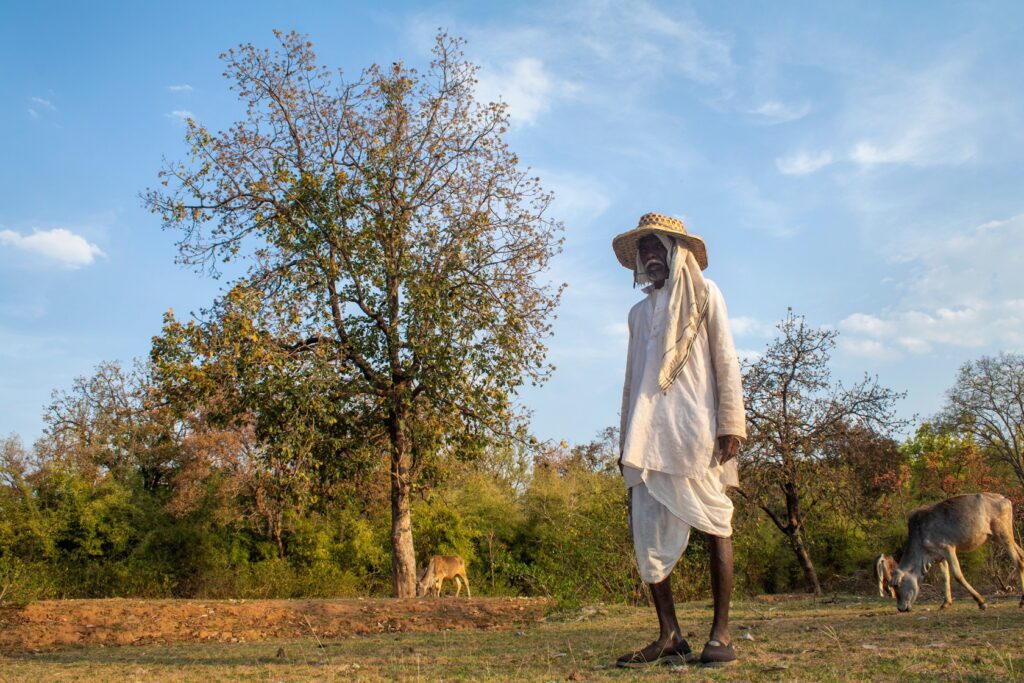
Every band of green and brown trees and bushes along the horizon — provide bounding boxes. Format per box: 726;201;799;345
0;323;1024;603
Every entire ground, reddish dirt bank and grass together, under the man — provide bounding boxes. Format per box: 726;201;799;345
0;595;1024;683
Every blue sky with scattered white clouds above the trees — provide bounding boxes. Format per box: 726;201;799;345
0;1;1024;442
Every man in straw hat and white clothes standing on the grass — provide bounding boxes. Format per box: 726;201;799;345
611;213;746;668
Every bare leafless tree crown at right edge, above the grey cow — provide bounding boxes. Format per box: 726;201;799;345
941;353;1024;486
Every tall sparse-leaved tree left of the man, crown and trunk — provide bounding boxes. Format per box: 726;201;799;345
145;33;560;596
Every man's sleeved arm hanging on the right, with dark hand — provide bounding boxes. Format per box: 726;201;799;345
708;287;746;463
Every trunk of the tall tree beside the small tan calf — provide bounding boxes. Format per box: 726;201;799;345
389;401;416;598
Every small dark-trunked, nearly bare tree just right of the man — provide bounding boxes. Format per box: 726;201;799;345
740;310;902;594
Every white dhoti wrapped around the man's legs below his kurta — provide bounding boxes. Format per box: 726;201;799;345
623;467;732;584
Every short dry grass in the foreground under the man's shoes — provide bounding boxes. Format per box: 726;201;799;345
0;596;1024;683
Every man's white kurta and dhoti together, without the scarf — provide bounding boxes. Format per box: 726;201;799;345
621;281;746;584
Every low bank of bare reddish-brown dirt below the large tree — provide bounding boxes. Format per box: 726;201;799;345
0;598;548;653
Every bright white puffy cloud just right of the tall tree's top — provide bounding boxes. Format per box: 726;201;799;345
476;57;577;125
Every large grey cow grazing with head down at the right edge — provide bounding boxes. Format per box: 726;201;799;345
892;494;1024;612
